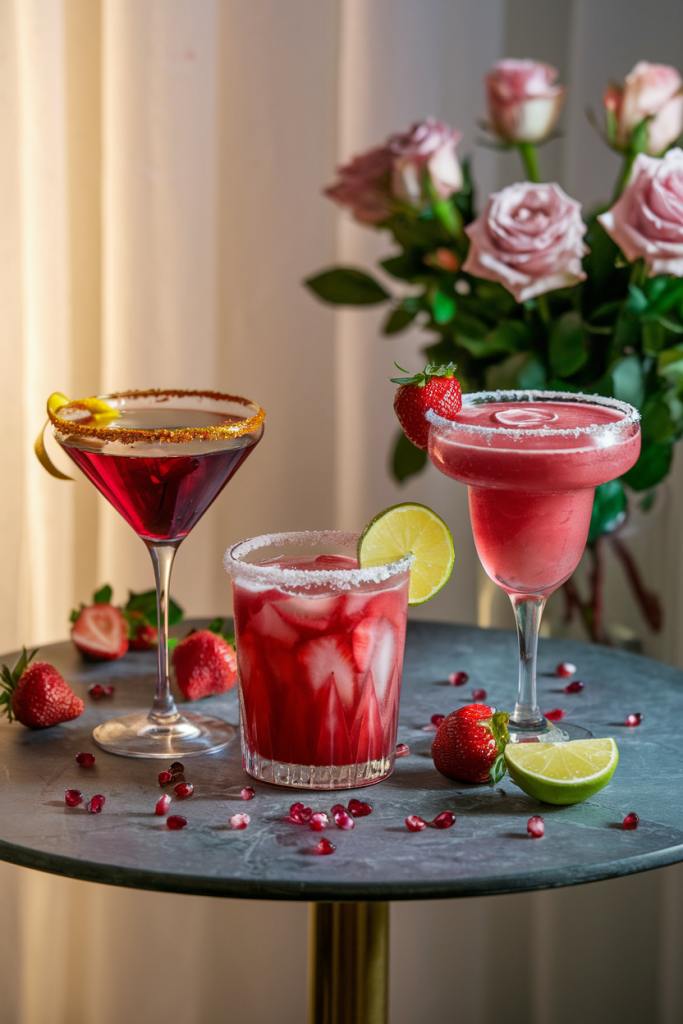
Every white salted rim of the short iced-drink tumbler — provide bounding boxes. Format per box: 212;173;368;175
223;529;413;590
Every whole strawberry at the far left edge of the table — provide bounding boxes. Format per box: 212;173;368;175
0;647;85;729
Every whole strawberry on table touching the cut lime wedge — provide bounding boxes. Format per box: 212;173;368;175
431;703;510;785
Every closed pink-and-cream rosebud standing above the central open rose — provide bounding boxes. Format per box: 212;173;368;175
485;58;566;142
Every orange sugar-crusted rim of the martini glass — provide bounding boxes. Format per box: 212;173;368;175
47;388;265;444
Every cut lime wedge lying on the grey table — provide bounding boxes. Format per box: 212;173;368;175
505;738;618;804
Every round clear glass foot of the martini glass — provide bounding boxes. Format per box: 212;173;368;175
92;712;238;761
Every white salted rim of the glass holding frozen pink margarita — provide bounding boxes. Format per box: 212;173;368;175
426;390;640;440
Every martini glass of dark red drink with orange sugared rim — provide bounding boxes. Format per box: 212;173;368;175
49;391;265;759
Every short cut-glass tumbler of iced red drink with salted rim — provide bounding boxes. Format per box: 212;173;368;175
224;530;411;790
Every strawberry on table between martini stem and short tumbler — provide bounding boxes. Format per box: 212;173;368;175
173;618;238;700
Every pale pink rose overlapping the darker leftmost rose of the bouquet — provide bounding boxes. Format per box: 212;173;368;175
387;118;463;206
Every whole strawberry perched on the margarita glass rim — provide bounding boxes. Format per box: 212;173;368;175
391;362;463;452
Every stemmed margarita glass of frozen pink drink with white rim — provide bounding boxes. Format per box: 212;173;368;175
427;391;640;742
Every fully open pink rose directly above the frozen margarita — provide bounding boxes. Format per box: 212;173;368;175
463;181;588;302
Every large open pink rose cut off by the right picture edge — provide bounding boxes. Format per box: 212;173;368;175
598;150;683;278
